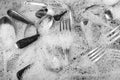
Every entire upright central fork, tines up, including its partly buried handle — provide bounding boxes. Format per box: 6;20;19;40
59;19;72;64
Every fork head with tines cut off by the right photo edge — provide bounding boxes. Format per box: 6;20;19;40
102;26;120;45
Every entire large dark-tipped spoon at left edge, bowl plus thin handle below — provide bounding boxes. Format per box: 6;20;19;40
0;16;16;65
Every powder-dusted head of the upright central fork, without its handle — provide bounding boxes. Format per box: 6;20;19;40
59;19;73;49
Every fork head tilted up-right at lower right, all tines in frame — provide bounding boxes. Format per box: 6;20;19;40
82;46;106;66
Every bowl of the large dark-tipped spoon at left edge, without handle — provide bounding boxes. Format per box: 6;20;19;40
0;16;16;48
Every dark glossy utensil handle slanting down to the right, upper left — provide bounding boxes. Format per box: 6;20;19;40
7;9;34;25
